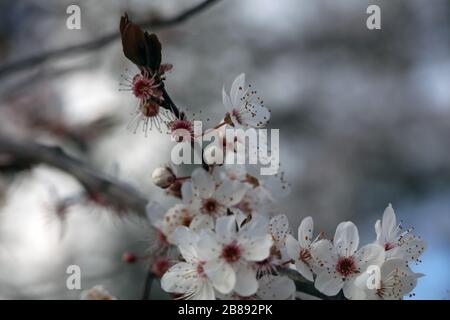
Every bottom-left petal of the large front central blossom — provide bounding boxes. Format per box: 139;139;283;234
203;259;236;294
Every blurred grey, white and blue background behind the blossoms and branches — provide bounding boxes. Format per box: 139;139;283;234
0;0;450;299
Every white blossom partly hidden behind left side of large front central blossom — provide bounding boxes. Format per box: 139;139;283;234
161;227;215;300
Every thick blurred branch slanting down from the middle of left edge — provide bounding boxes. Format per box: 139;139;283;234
0;134;147;217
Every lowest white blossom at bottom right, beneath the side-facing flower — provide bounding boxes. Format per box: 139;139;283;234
351;258;423;300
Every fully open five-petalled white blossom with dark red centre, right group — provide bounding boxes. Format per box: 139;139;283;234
312;222;384;297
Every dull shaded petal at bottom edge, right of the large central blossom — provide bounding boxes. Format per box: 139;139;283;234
256;275;296;300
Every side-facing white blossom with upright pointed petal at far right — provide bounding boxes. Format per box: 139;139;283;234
375;205;425;262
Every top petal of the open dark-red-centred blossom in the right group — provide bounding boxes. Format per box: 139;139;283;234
333;221;359;257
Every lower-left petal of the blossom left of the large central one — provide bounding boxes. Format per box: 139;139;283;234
161;262;198;293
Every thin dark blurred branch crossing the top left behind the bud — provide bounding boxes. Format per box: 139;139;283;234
0;0;220;78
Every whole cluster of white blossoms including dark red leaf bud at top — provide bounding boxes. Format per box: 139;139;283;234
115;16;425;299
